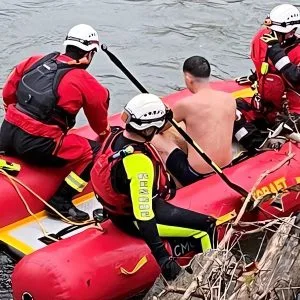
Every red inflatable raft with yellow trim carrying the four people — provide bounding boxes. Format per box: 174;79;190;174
0;81;300;300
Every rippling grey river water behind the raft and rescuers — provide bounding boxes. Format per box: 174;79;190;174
0;0;299;300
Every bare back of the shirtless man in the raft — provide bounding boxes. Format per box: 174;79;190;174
173;88;236;174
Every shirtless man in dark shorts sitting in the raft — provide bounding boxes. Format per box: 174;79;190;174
152;56;236;186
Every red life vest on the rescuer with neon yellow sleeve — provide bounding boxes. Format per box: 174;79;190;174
91;129;175;215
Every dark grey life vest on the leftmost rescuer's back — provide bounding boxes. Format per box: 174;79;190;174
16;52;75;131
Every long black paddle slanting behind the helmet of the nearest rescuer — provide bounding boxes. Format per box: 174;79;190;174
101;44;248;197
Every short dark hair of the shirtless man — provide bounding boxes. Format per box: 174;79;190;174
183;55;210;78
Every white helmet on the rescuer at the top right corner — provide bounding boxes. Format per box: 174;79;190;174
267;4;300;33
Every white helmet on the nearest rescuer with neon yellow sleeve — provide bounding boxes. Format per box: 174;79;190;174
122;94;166;130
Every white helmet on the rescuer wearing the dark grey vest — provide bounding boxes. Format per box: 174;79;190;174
64;24;99;52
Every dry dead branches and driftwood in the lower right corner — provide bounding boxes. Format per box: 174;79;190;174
144;144;300;300
